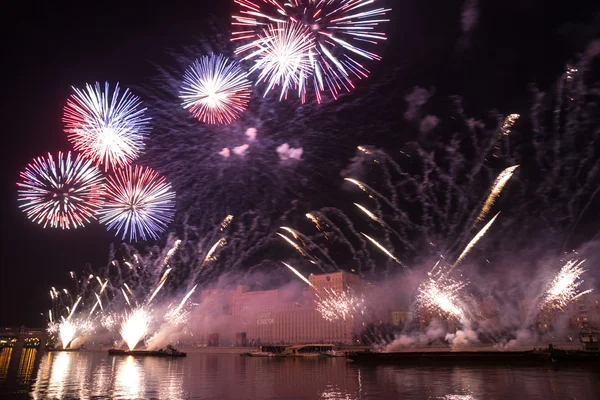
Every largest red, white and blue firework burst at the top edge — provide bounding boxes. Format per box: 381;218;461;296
232;0;390;102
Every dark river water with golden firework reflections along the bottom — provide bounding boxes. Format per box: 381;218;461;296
0;349;600;400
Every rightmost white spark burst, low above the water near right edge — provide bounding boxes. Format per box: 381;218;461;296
541;259;593;310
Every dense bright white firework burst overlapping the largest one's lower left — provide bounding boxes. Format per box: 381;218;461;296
236;22;315;102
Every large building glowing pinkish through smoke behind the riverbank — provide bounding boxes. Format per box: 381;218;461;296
195;272;361;345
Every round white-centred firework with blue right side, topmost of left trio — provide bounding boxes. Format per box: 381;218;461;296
63;82;150;170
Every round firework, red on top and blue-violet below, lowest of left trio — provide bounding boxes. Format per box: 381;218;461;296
98;166;175;241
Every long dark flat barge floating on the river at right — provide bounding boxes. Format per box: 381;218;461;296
347;350;600;365
